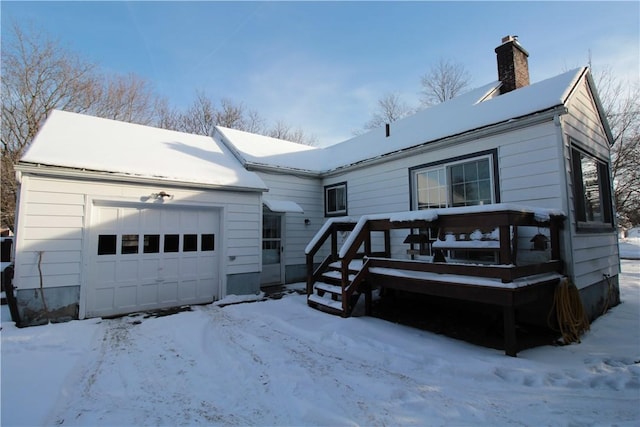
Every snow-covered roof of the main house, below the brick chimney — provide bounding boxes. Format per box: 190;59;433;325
214;68;586;173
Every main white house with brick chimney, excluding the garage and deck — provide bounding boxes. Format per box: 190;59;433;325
213;37;619;318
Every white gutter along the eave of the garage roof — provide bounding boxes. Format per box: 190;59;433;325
15;162;269;193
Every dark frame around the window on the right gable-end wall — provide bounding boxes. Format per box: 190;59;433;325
570;145;615;233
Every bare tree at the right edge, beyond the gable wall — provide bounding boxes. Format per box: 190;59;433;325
594;68;640;226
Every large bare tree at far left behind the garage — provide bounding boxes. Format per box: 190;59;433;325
0;25;165;228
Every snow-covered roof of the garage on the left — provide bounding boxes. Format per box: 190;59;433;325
21;110;267;191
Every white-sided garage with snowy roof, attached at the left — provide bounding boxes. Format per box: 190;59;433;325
13;111;267;326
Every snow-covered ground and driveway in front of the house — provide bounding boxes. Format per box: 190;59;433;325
1;260;640;426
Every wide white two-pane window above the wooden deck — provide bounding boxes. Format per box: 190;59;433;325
413;155;495;210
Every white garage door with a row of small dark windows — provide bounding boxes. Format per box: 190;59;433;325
85;206;220;317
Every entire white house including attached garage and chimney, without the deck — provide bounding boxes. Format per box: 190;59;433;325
14;37;619;328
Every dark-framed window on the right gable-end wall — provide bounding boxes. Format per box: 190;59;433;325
571;147;613;230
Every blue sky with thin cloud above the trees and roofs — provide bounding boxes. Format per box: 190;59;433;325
0;1;640;145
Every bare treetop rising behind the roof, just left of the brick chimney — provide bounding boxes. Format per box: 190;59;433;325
420;58;471;106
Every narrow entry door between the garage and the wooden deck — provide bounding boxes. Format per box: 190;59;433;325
260;212;284;285
